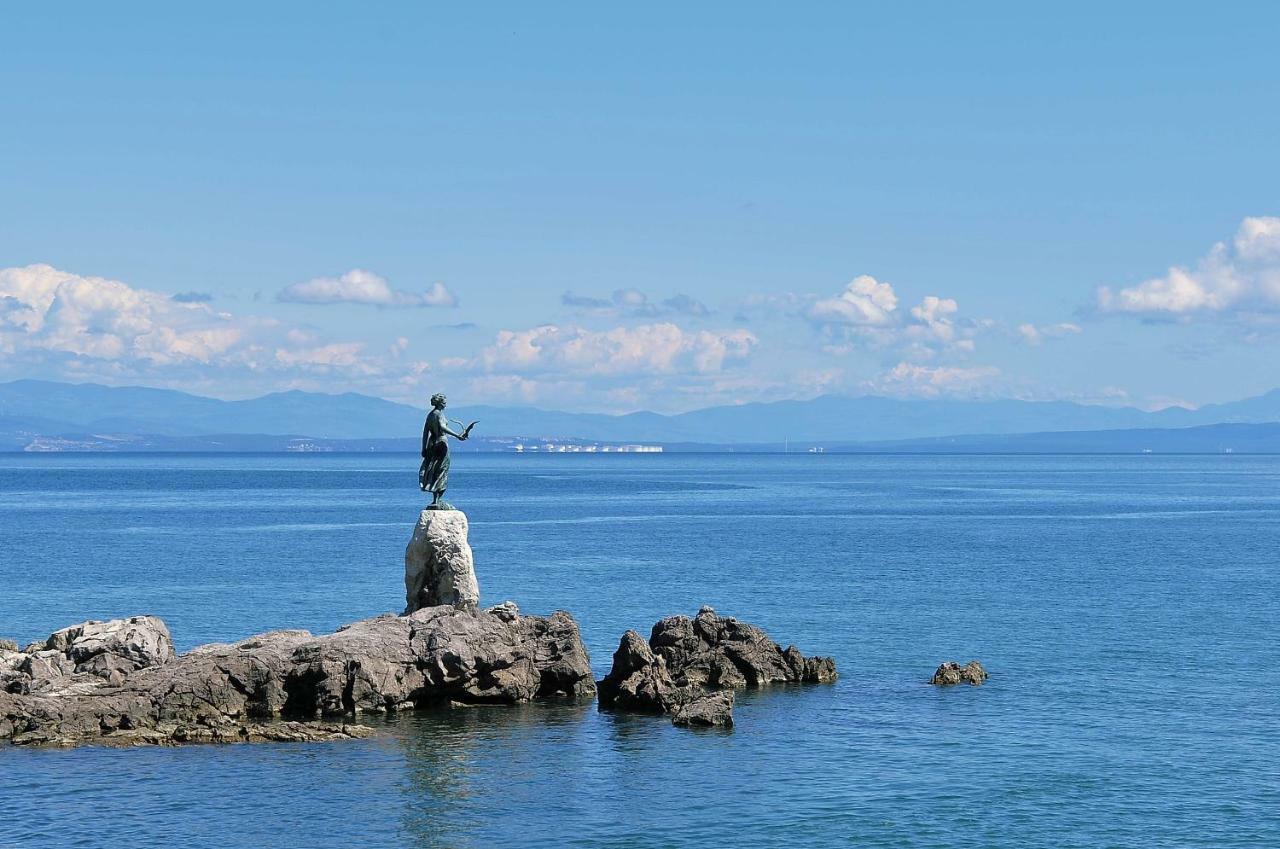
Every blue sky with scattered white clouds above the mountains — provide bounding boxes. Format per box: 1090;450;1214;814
0;3;1280;412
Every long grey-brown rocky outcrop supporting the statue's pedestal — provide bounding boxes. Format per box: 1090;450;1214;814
0;603;595;745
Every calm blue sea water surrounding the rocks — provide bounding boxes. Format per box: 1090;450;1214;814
0;455;1280;849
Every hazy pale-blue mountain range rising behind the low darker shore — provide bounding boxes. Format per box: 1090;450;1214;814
0;380;1280;451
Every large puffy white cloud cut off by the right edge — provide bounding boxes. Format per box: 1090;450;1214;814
1097;218;1280;318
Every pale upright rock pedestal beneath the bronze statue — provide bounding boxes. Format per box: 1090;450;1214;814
404;510;480;615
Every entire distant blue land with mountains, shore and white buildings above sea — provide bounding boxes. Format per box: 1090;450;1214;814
0;380;1280;455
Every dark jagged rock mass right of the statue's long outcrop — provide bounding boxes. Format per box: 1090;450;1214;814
599;607;836;726
